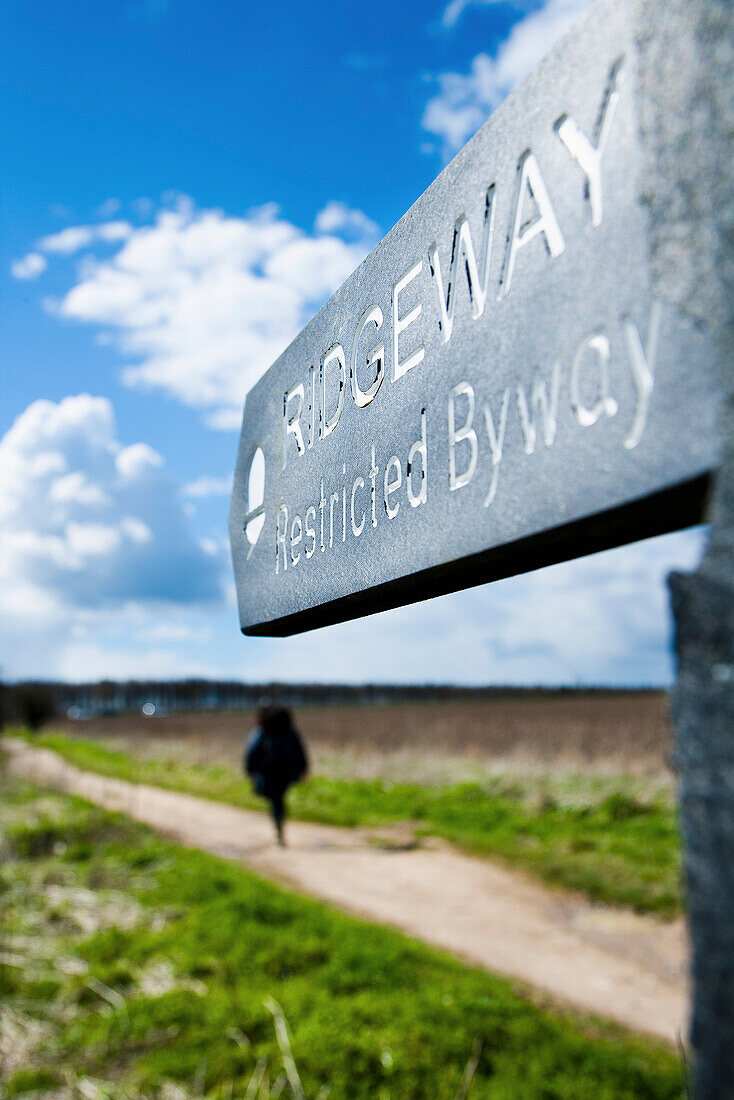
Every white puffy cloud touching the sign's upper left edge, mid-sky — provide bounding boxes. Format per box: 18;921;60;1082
27;195;377;430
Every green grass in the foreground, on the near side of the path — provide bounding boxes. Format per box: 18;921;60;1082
0;780;682;1100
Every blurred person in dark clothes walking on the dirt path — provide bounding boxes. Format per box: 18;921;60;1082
242;706;308;847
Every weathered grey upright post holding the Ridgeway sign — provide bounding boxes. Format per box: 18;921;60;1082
638;0;734;1082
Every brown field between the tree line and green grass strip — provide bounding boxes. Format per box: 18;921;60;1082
54;692;670;782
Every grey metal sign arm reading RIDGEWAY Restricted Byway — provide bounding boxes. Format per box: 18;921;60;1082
230;0;717;635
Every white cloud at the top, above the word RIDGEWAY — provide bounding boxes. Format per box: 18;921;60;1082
421;0;590;158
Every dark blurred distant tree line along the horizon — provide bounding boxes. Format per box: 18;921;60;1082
0;680;655;729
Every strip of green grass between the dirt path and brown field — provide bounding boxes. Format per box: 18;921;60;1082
12;734;681;917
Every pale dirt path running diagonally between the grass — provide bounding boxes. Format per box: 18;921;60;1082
3;740;687;1044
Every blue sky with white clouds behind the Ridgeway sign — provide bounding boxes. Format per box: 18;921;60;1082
0;0;702;683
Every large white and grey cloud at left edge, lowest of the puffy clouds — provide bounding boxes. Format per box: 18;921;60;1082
0;394;222;626
